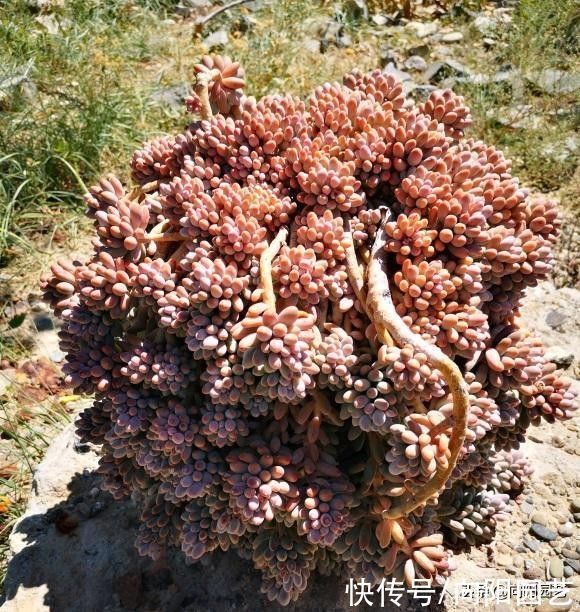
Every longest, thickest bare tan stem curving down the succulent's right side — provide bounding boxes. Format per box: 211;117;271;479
367;209;469;519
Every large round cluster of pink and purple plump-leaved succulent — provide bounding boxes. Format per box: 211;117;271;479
43;57;576;604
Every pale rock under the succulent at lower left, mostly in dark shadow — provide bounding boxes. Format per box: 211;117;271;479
2;427;443;612
